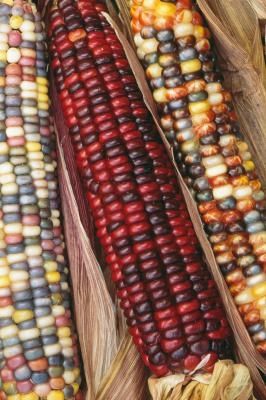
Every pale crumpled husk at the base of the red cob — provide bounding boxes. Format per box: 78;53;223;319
149;360;255;400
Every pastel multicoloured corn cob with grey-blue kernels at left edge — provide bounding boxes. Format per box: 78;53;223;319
0;0;80;400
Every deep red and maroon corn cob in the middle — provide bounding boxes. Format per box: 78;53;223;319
48;0;233;376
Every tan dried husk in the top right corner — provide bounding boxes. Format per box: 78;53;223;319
197;0;266;185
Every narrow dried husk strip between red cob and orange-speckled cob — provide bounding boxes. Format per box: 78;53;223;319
103;5;266;400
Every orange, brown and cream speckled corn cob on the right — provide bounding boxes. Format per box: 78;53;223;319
131;0;266;354
